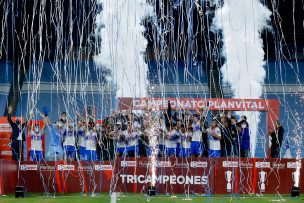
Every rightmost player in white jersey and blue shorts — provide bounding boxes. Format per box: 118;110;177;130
208;120;222;157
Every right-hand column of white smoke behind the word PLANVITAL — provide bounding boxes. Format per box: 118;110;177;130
213;0;271;157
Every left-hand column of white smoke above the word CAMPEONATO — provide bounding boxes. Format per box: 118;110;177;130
95;0;153;97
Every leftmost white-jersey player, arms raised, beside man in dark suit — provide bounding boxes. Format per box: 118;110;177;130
28;115;45;161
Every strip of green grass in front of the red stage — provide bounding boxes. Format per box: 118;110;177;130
0;194;304;203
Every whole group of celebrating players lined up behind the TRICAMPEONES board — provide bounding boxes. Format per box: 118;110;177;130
27;106;256;161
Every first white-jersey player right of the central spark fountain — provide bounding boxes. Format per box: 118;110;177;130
165;124;178;157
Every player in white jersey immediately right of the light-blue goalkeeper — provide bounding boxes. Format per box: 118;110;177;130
63;121;76;161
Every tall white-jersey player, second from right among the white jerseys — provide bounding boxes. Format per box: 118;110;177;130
190;114;202;157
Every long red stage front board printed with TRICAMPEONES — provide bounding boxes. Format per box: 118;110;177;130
0;158;304;194
